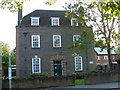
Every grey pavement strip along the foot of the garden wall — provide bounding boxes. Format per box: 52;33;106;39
39;82;120;90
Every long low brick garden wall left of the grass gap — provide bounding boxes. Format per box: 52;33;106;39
3;75;75;88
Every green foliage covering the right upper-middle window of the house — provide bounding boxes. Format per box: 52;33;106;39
68;26;94;53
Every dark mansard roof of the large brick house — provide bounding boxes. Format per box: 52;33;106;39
21;10;70;26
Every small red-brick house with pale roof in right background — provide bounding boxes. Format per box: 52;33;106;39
95;47;118;70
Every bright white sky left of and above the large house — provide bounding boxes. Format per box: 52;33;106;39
0;0;70;49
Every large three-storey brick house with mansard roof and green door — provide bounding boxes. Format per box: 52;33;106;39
16;10;95;78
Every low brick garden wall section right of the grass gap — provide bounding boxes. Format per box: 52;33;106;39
85;71;120;84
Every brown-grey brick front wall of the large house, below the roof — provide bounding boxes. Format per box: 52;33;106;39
16;26;95;78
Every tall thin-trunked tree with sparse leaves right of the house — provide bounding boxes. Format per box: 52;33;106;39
65;1;119;70
